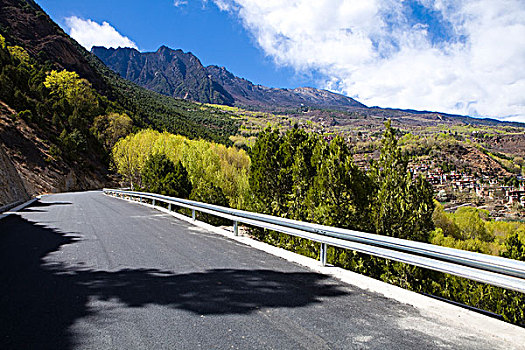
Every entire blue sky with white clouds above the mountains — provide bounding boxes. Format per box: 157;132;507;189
37;0;525;122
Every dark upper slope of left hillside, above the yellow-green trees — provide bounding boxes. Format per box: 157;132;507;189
0;0;236;142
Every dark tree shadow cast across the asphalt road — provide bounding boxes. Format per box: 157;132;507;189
0;215;347;349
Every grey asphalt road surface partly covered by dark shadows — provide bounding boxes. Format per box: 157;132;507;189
0;192;516;350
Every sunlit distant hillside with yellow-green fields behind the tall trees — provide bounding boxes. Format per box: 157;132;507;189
214;102;525;178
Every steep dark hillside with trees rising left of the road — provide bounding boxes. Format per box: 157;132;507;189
0;0;238;207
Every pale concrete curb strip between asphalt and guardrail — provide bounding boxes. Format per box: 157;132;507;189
107;194;525;349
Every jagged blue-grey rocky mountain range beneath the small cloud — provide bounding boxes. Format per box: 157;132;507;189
91;46;366;110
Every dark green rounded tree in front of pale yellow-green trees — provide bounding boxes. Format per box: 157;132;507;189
142;153;192;198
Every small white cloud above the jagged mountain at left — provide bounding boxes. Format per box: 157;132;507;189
65;16;138;50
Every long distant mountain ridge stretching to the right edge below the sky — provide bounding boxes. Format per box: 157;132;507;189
91;45;525;126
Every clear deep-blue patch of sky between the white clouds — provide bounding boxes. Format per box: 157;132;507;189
37;0;314;88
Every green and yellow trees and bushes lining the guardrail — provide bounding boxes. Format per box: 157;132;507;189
113;123;525;325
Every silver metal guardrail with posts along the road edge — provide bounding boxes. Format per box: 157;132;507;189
103;189;525;293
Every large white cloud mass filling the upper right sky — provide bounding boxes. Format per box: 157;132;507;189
213;0;525;122
